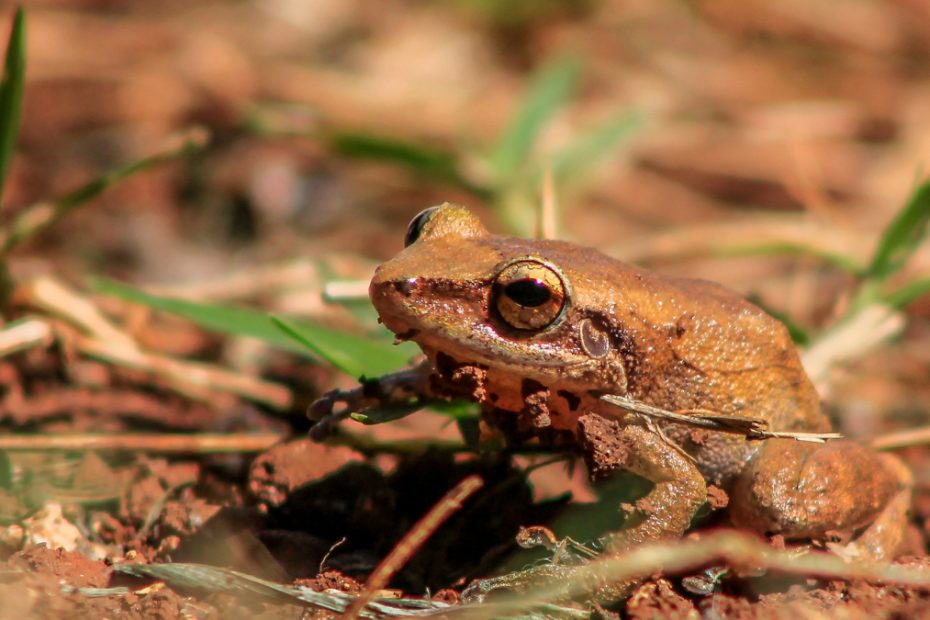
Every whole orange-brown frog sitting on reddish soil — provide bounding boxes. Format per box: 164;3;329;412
314;203;913;600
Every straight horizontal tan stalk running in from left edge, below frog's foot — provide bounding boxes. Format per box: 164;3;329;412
0;433;287;454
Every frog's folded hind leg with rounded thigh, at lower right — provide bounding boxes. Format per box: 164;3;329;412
729;439;912;559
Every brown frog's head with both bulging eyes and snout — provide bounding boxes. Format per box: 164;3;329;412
369;204;625;391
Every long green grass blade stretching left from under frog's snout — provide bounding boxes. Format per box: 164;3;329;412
95;279;416;377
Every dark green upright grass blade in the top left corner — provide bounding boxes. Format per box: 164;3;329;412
0;7;26;207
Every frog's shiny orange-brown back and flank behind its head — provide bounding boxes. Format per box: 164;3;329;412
491;239;826;430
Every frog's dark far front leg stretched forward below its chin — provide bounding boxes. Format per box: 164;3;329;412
307;361;435;441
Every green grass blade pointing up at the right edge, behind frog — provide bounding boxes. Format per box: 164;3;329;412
866;181;930;282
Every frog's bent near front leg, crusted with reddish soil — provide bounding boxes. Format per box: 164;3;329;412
578;414;707;553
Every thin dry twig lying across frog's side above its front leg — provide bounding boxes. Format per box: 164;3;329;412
601;394;843;443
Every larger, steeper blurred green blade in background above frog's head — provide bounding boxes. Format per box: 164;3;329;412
488;56;579;182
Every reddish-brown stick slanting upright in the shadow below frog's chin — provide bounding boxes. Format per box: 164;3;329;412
346;475;484;620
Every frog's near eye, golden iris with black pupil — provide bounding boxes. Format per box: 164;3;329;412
492;260;567;330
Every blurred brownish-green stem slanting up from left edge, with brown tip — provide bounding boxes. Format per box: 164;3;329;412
0;130;208;257
